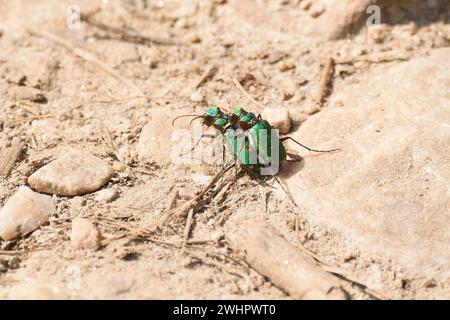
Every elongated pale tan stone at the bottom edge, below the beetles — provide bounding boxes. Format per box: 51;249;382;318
227;219;347;300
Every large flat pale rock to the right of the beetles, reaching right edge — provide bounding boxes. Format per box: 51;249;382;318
281;49;450;279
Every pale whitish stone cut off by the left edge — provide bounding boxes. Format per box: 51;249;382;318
0;186;55;241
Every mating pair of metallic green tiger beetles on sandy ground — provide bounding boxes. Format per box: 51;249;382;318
172;106;340;175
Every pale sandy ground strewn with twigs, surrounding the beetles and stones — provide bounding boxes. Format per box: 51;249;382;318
0;0;450;299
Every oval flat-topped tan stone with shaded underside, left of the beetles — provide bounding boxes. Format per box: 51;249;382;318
28;150;113;196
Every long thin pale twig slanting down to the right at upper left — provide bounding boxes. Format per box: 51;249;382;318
28;30;149;100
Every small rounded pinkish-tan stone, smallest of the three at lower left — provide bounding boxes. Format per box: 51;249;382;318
70;218;102;250
